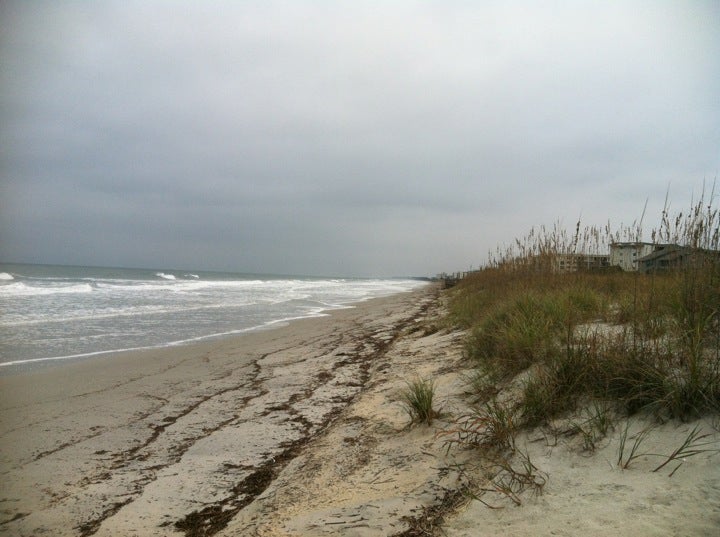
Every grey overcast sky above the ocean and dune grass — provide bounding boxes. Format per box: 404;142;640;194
0;0;720;276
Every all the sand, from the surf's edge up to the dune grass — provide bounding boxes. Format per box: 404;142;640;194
0;286;720;537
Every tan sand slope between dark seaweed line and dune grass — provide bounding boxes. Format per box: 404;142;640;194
221;322;472;536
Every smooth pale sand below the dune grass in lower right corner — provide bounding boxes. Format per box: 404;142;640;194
444;418;720;537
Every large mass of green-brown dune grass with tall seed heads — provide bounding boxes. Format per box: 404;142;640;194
449;184;720;428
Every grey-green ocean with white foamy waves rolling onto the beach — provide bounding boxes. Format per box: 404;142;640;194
0;264;424;370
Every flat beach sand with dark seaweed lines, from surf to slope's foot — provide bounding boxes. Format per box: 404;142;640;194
0;286;466;536
